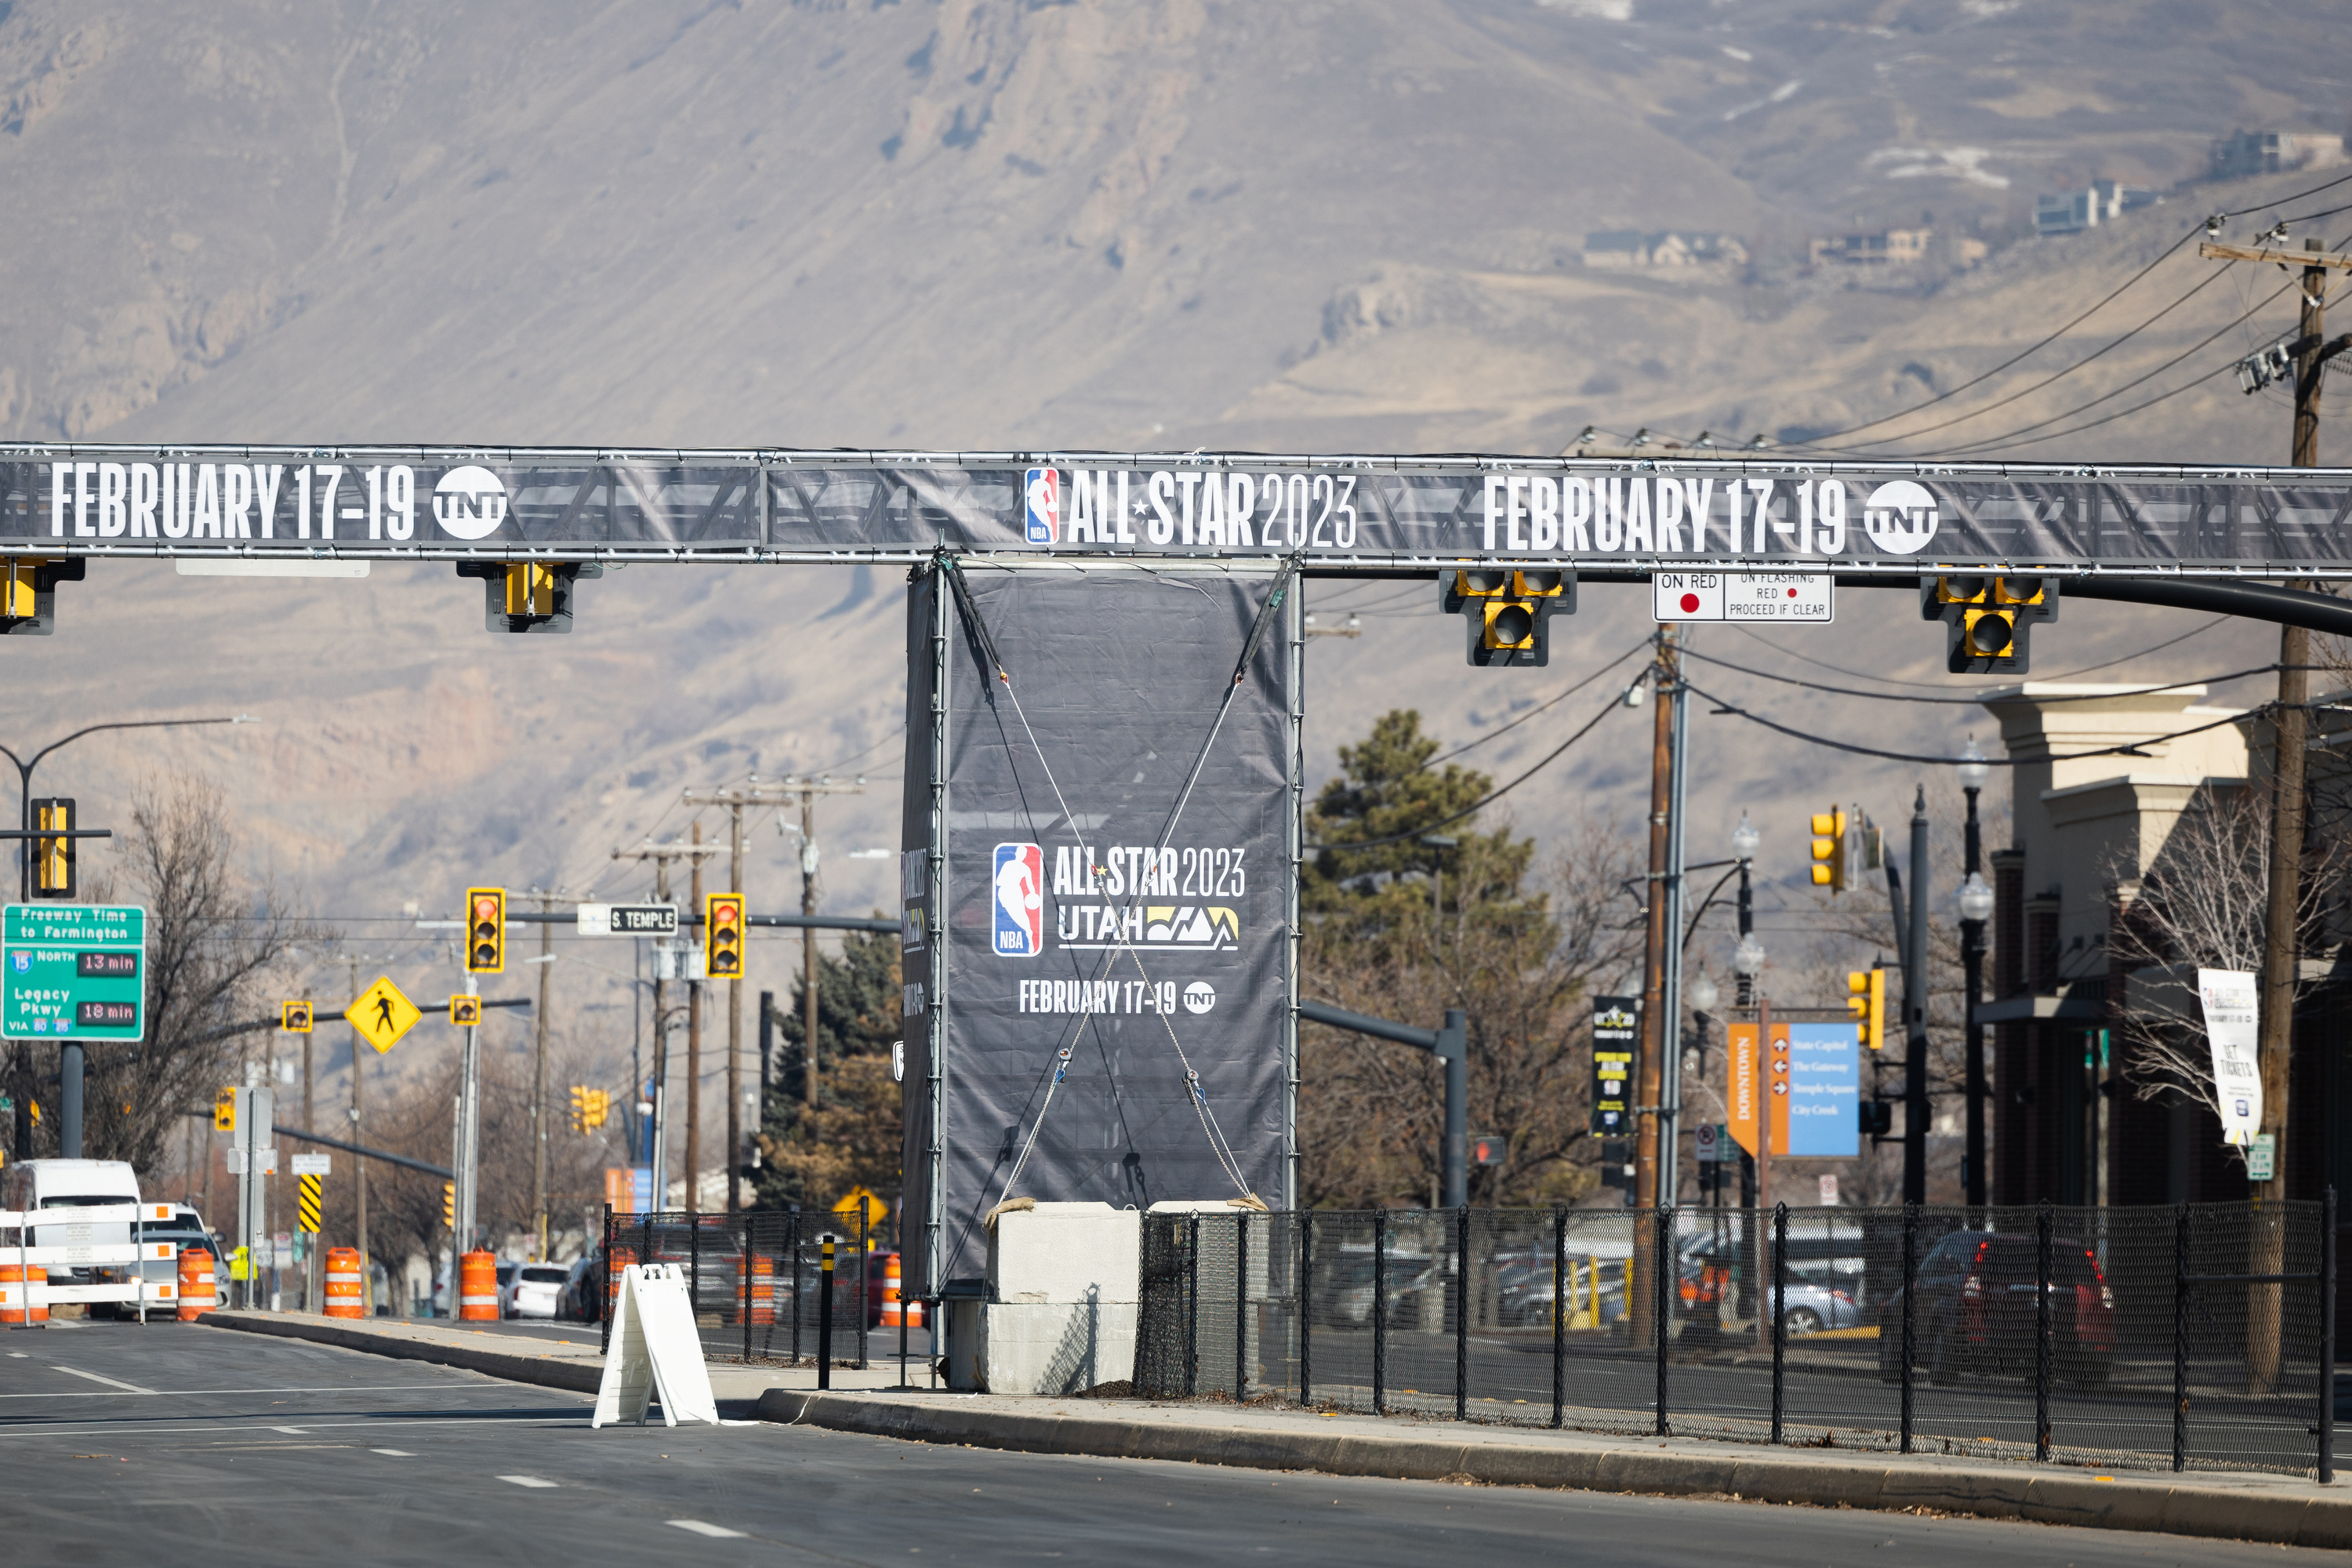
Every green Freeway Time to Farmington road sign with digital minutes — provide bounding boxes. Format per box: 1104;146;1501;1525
0;902;146;1039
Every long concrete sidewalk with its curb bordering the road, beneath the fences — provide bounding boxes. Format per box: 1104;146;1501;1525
202;1312;2352;1549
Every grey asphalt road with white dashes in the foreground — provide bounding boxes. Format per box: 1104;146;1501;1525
0;1323;2324;1568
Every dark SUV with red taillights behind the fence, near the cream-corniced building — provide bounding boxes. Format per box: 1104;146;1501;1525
1877;1229;2114;1389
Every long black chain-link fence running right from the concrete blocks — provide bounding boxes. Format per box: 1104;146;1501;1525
1136;1192;2336;1479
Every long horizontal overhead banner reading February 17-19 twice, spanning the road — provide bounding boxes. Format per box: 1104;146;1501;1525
13;445;2352;576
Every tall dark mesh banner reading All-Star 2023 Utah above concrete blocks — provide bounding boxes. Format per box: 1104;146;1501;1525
901;571;1298;1283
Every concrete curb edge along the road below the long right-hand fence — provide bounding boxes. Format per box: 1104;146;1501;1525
757;1389;2352;1549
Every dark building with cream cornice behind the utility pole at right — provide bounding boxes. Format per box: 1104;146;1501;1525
1978;682;2352;1203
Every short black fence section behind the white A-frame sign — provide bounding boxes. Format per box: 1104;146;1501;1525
593;1208;882;1366
